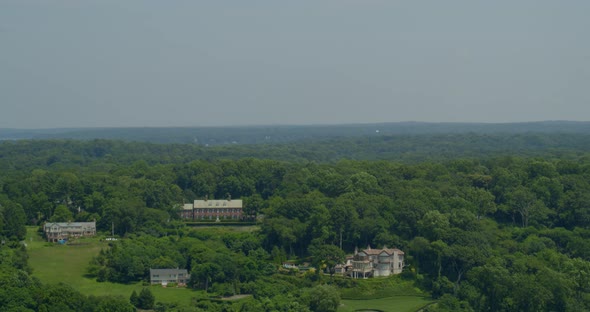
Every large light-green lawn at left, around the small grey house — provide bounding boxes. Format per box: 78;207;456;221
27;227;203;307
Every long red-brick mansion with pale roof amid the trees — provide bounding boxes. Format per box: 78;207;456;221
180;198;244;221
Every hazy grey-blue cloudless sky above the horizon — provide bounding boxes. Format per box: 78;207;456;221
0;0;590;128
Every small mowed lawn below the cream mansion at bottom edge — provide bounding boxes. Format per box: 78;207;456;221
338;296;433;312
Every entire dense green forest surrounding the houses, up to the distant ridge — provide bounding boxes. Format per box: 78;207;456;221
0;133;590;311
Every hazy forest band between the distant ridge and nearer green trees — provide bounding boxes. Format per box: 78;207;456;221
0;132;590;172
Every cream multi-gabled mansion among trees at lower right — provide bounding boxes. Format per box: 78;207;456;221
351;247;404;278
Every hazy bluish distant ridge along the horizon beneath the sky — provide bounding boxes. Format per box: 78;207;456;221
0;121;590;146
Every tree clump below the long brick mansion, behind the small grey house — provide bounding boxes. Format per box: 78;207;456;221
88;230;272;295
